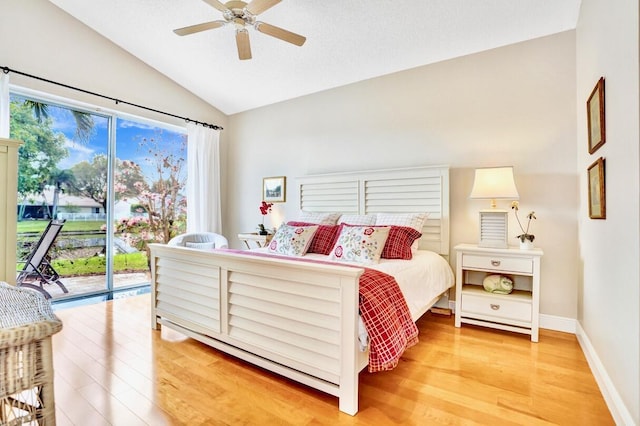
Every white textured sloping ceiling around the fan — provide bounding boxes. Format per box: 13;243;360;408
50;0;580;114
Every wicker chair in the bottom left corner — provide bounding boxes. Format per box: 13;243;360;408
0;282;62;426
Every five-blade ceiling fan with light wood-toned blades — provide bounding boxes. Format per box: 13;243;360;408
173;0;307;60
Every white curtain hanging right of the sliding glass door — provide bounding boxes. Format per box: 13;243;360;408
187;123;222;233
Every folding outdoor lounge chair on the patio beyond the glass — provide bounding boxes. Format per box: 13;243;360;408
16;220;69;299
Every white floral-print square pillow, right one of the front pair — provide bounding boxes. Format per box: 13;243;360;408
329;225;391;265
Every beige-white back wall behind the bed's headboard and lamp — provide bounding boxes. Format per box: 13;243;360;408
230;31;578;318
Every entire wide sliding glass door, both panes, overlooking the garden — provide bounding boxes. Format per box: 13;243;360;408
10;94;186;299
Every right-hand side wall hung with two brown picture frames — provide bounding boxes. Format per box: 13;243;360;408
576;0;640;425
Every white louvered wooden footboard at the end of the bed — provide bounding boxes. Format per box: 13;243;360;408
151;244;366;415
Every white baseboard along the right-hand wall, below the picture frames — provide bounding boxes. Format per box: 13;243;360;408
576;321;635;425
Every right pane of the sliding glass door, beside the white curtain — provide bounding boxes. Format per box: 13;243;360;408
113;118;187;288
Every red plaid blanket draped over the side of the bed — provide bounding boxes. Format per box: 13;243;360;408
360;268;418;373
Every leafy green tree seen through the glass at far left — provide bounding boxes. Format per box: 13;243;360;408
10;102;68;219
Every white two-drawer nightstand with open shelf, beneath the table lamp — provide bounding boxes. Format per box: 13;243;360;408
455;244;543;342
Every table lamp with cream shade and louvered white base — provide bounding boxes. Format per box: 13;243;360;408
469;167;519;248
